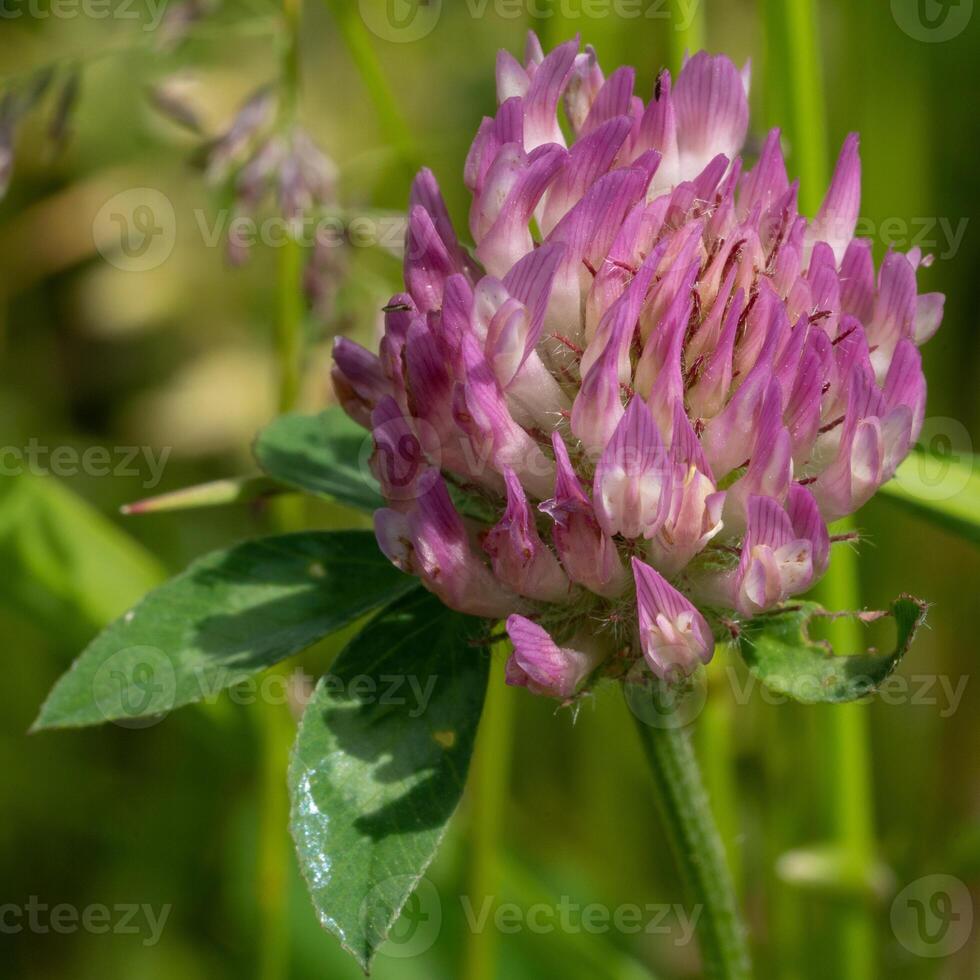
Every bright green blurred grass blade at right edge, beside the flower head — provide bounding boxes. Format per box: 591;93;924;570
881;450;980;545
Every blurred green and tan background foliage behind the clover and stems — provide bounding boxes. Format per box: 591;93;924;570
0;0;980;980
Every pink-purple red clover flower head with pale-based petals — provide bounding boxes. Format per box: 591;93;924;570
334;35;943;699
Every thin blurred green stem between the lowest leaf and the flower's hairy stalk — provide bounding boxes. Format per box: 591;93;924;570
462;644;513;980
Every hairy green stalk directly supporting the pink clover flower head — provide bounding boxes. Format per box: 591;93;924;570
634;683;751;980
